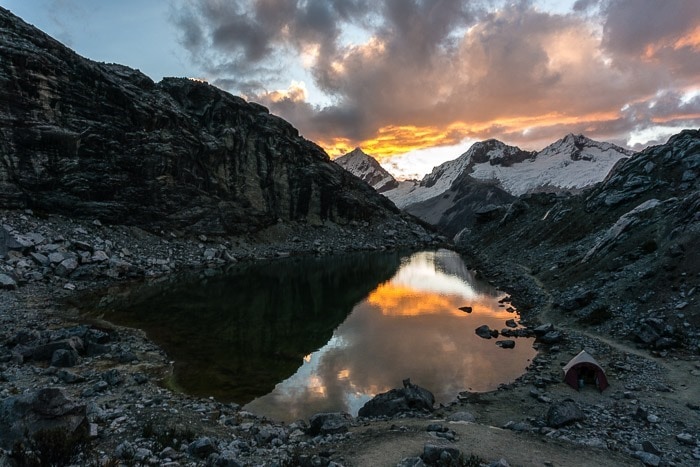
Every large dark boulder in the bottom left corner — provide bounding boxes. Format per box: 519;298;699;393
0;388;88;449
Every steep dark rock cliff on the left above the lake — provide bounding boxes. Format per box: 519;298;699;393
0;8;398;234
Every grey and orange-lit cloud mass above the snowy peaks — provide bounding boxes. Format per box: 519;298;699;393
174;0;700;159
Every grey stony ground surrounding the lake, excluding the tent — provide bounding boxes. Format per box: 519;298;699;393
0;211;700;466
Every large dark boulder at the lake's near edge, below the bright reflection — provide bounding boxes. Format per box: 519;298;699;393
358;379;435;417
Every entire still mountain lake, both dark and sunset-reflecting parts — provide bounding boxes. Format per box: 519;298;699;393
89;250;535;421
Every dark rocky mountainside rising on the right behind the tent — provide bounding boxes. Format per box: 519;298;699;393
457;130;700;352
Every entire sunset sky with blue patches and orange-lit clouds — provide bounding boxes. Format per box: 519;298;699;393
5;0;700;178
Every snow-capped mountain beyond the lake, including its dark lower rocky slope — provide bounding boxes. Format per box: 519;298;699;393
384;134;633;235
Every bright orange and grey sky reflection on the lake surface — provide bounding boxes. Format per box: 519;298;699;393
246;250;535;420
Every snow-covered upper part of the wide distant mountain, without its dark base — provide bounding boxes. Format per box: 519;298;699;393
385;134;633;208
